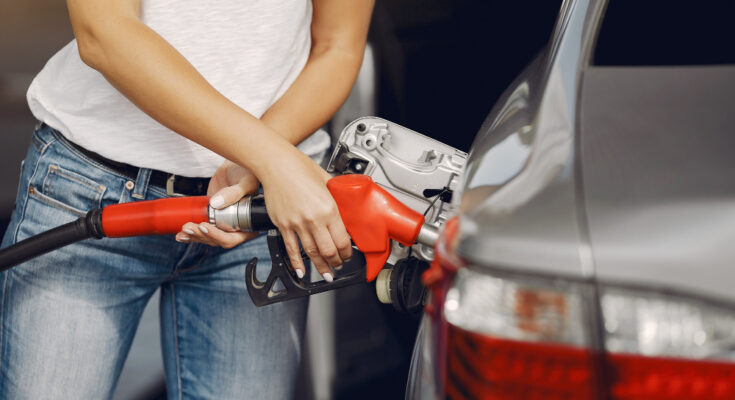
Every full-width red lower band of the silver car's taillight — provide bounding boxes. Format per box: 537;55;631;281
446;325;735;400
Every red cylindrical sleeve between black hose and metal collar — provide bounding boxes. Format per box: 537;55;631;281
102;196;209;237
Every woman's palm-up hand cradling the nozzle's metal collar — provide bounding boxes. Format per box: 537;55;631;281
176;161;259;249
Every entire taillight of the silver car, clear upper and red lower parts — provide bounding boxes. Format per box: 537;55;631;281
437;257;735;400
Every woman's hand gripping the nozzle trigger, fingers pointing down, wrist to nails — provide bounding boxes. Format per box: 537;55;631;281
259;148;352;282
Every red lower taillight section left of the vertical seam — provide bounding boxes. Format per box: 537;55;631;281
446;325;596;400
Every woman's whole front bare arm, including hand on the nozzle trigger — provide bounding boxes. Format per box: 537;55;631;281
67;0;360;269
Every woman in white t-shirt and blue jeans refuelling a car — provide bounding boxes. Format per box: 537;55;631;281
0;0;373;399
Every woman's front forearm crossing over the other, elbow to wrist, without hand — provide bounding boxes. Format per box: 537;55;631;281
72;16;291;177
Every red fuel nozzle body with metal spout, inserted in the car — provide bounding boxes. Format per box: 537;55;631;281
327;175;424;282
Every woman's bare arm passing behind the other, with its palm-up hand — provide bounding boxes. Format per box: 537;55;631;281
177;0;374;279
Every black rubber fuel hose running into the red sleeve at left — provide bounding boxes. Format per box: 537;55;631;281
0;209;105;272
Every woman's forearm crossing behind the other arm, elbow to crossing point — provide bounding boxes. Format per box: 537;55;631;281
261;45;364;144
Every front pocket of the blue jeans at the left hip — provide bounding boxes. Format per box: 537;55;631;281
29;164;107;216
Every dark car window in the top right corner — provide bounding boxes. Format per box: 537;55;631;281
592;0;735;66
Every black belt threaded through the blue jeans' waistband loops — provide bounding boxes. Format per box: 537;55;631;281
69;137;209;196
